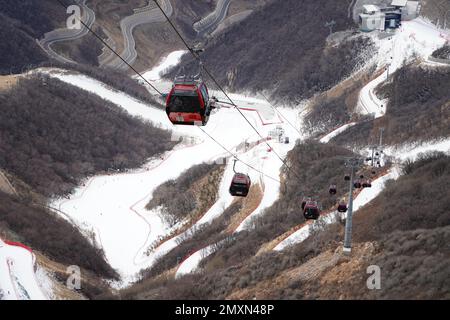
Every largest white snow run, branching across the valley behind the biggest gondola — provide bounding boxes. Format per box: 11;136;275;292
47;55;299;286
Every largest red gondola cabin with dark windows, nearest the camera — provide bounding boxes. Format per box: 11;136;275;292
166;77;214;126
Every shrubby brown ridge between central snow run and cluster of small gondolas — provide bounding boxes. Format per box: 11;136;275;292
120;141;372;299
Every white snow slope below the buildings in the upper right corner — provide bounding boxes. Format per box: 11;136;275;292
357;18;448;118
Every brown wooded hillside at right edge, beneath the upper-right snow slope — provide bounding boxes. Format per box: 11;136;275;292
333;66;450;146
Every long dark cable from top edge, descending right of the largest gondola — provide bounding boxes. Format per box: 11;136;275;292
149;0;300;179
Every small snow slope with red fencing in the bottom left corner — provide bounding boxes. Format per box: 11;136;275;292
0;239;50;300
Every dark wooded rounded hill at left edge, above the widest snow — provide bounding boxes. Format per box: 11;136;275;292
0;78;173;196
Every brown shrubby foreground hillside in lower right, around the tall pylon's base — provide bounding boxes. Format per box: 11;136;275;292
122;154;450;299
